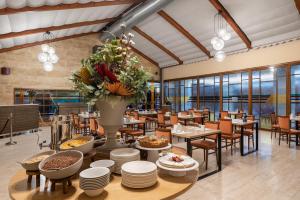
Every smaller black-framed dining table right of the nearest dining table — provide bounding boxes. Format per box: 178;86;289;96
232;119;258;156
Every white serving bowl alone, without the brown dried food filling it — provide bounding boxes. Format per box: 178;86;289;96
39;150;83;179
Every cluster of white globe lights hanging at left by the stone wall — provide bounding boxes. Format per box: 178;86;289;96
38;31;59;72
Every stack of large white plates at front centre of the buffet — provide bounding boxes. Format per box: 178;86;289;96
121;161;157;188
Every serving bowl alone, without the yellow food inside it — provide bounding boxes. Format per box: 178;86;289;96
59;136;94;154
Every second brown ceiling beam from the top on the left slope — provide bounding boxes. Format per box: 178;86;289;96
0;18;116;39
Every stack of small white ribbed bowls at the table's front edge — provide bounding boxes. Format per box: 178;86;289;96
79;167;110;197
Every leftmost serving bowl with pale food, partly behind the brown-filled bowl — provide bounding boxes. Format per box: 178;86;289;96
20;150;55;171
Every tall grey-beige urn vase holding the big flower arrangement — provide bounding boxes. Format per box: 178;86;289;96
95;96;128;154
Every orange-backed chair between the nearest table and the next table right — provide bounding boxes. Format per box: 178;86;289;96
219;119;241;155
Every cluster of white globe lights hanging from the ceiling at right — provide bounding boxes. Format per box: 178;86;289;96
210;13;231;62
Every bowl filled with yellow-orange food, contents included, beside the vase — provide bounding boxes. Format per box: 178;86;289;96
59;136;94;154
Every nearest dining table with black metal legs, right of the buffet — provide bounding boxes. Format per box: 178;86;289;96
171;126;222;180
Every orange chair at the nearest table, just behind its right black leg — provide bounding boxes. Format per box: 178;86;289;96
191;122;219;170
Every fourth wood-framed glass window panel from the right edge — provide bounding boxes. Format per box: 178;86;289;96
199;76;220;120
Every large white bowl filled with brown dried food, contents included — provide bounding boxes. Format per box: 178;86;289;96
39;150;83;179
